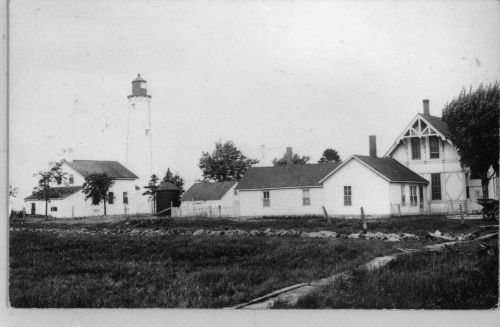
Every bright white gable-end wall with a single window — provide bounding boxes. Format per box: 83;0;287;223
323;159;391;216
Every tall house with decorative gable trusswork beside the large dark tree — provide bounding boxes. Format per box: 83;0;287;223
385;100;498;213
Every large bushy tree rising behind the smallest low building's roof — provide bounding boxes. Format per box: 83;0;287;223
198;141;259;182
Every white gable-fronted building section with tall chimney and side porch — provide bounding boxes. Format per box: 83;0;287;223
320;144;428;217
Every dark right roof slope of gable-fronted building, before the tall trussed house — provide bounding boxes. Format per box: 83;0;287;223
353;155;429;184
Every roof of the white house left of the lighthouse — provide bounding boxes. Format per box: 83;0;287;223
65;160;138;179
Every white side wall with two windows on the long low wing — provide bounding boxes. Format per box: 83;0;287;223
239;187;324;217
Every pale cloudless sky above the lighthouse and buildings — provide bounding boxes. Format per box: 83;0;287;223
9;0;500;208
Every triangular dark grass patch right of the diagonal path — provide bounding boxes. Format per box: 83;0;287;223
275;239;498;309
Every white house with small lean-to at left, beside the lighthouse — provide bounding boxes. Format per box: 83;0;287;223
24;160;147;218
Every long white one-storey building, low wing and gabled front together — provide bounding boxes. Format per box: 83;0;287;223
236;136;428;217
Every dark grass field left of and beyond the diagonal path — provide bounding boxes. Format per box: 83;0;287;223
9;217;500;308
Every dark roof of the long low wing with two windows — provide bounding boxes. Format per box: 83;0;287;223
236;163;340;190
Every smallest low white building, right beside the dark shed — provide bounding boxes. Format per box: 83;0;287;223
178;182;237;217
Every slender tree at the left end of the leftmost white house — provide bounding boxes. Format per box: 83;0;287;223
33;162;67;218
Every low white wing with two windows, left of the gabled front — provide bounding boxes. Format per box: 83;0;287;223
235;163;339;217
